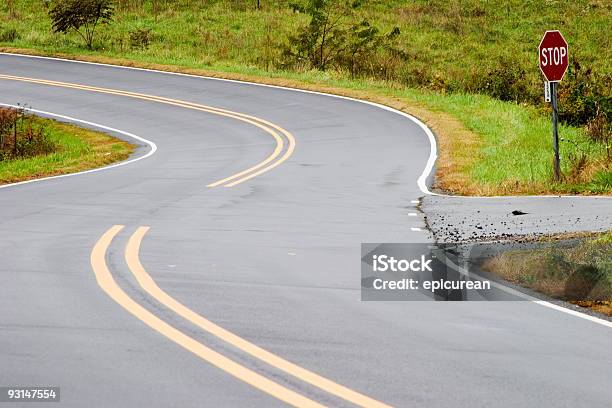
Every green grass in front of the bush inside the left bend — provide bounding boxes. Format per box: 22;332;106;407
0;119;134;184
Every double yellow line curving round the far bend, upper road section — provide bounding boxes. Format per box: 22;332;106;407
0;74;295;187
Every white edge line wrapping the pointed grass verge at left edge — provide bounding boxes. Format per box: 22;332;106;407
0;103;157;189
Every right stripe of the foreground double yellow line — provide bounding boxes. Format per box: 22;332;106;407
125;227;389;408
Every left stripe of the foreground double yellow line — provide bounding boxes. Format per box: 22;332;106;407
91;225;324;408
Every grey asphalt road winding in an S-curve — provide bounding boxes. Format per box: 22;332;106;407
0;55;612;407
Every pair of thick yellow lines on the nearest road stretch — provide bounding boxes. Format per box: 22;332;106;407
91;225;389;408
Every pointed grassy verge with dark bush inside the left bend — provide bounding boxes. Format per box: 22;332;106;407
0;108;134;184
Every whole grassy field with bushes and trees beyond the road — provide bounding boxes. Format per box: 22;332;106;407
0;0;612;195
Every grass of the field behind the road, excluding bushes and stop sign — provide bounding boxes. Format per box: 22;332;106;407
0;0;612;195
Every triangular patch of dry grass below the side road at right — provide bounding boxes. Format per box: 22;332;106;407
484;231;612;316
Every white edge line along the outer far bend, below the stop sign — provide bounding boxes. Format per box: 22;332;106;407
0;52;612;200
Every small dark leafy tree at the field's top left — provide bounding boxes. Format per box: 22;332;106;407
49;0;115;49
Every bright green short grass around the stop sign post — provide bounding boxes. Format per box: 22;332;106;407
402;94;611;193
